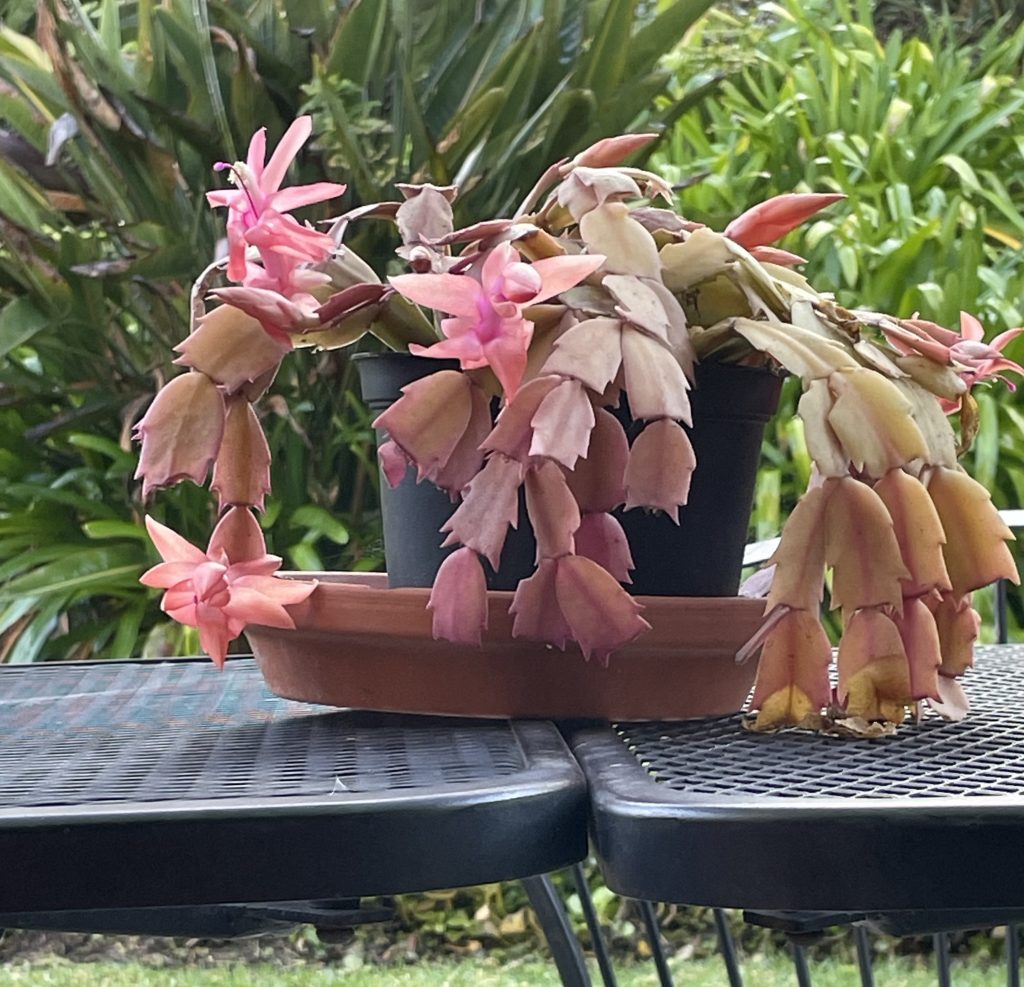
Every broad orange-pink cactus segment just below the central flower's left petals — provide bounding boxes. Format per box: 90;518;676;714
374;371;473;479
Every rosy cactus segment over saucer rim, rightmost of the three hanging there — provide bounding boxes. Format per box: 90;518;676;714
555;555;650;664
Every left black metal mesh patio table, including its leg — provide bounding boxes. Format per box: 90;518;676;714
0;659;589;985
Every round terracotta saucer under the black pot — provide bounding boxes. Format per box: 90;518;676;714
246;572;764;720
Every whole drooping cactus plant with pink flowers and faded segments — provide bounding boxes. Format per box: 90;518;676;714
137;118;1022;729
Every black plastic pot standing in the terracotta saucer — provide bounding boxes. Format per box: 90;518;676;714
355;353;782;596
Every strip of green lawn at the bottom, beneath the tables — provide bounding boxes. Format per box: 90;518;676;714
0;954;1006;987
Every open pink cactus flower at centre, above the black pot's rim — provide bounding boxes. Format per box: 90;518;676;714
391;244;604;397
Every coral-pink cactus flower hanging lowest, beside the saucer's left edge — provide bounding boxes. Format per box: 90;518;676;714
139;517;315;667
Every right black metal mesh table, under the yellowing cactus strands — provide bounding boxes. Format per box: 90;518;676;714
570;646;1024;918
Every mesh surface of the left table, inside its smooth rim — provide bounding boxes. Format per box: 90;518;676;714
0;660;526;809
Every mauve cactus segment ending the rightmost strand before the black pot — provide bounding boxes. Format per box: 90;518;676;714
626;418;697;524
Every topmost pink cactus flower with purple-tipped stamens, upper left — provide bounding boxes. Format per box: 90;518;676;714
206;116;345;282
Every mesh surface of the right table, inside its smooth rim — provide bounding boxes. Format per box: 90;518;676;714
615;645;1024;799
